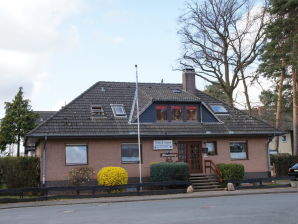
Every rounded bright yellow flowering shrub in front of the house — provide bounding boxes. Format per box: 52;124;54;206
97;166;128;186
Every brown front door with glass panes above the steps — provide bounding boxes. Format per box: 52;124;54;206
178;142;203;173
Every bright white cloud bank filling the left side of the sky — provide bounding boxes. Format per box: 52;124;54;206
0;0;84;116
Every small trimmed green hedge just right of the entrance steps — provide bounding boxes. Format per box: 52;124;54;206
216;163;244;183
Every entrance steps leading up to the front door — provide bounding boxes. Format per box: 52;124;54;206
189;173;224;191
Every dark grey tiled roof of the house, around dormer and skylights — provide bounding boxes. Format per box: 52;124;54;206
27;82;280;137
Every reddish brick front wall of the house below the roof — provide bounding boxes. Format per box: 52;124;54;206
39;138;268;181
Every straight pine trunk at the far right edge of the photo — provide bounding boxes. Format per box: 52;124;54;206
292;66;298;156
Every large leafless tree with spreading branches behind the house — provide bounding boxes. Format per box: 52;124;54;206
178;0;265;107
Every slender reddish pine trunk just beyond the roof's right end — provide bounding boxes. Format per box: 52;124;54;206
275;71;285;151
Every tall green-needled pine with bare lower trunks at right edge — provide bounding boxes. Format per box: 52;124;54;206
259;0;298;155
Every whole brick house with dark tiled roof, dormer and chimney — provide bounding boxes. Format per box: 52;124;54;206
25;70;282;185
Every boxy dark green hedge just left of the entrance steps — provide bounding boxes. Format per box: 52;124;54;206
150;162;189;182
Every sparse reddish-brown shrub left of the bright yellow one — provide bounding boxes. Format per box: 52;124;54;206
69;167;94;186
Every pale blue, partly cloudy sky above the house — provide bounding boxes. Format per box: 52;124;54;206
0;0;261;117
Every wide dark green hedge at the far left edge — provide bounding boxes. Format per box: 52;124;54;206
0;157;40;188
